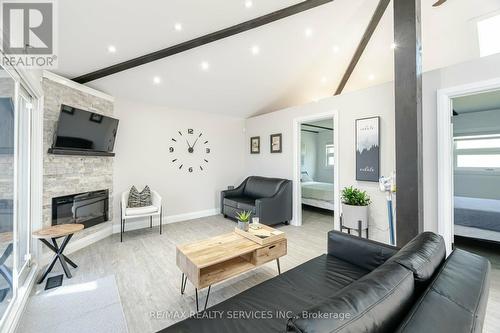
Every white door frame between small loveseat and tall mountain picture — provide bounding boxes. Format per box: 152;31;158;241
292;110;340;230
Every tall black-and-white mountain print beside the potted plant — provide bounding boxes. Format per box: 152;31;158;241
356;116;380;182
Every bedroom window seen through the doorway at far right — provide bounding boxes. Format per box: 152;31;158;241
454;135;500;172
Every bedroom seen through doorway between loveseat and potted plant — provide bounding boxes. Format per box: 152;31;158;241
300;117;335;222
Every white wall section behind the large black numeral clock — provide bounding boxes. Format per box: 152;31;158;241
114;98;246;224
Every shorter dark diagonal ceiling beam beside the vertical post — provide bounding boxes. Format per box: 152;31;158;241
335;0;391;95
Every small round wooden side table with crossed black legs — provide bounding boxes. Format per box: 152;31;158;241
33;223;84;284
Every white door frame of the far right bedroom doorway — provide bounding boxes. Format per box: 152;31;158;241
437;78;500;254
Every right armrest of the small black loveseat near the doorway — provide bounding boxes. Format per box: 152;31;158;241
255;180;292;224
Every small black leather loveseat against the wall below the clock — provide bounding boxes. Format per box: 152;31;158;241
221;176;292;225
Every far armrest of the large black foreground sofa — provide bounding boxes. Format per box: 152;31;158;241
328;230;398;271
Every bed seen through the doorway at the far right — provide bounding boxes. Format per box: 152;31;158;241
454;196;500;231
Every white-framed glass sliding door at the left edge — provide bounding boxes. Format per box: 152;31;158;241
0;63;33;319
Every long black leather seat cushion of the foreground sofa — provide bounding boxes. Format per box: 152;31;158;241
161;255;368;333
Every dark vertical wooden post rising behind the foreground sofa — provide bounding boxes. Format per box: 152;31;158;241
394;0;424;247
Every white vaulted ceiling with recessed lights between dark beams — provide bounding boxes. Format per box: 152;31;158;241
56;0;500;117
